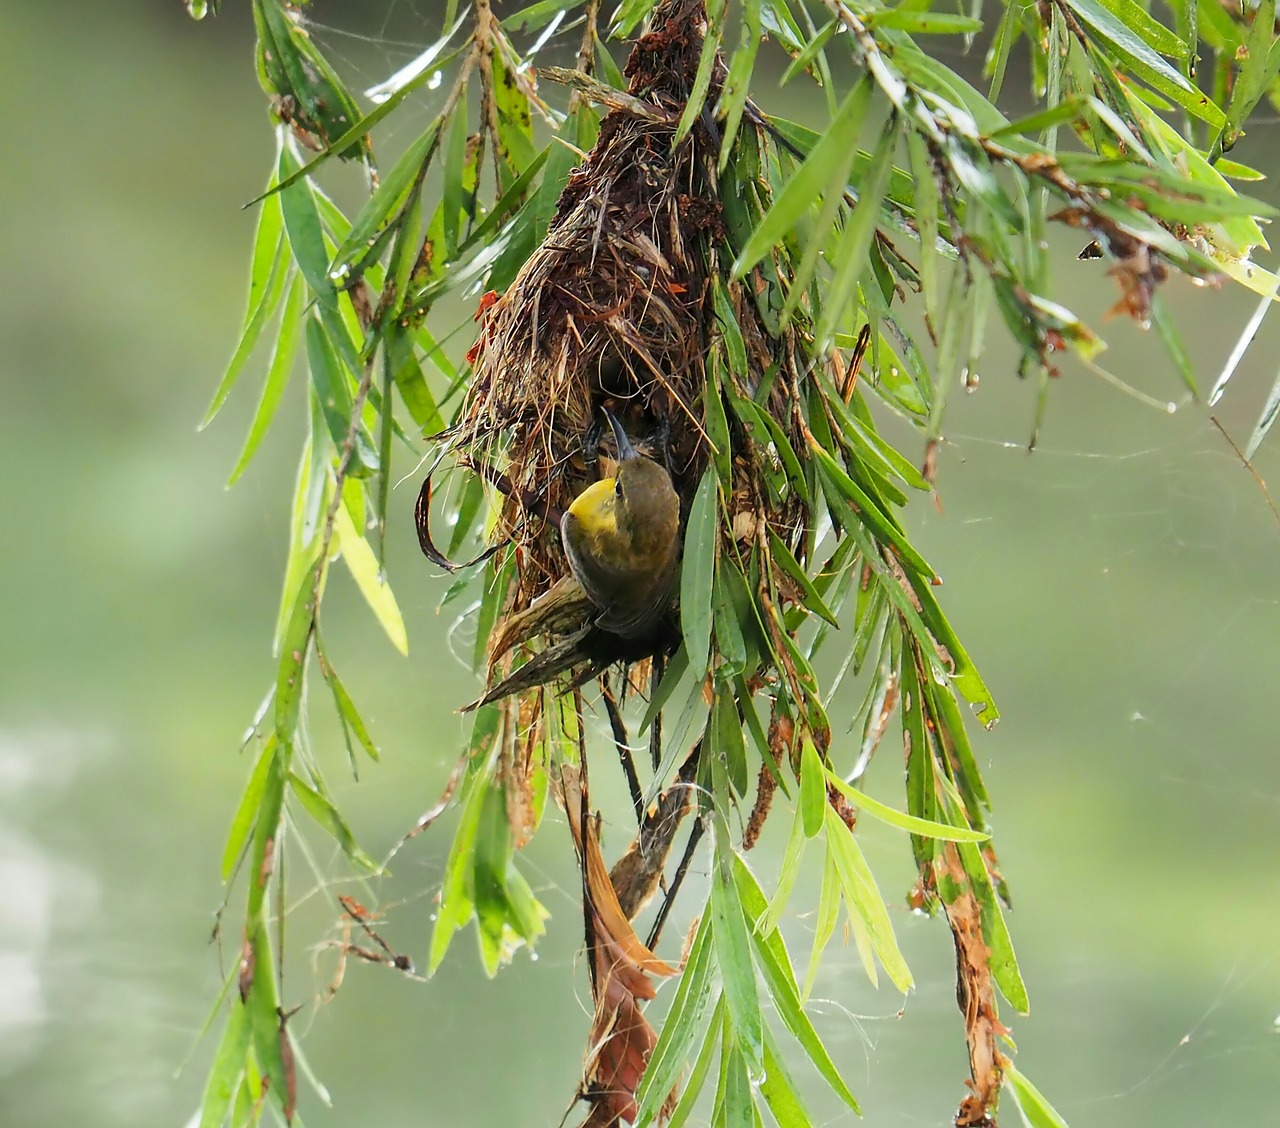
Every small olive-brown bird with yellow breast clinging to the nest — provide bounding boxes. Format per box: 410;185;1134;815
561;411;680;639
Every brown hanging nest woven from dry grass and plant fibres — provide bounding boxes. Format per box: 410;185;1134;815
451;0;803;660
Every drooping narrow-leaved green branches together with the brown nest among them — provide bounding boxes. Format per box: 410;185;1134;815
188;0;1280;1128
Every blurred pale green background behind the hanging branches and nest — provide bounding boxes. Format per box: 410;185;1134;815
0;0;1280;1128
